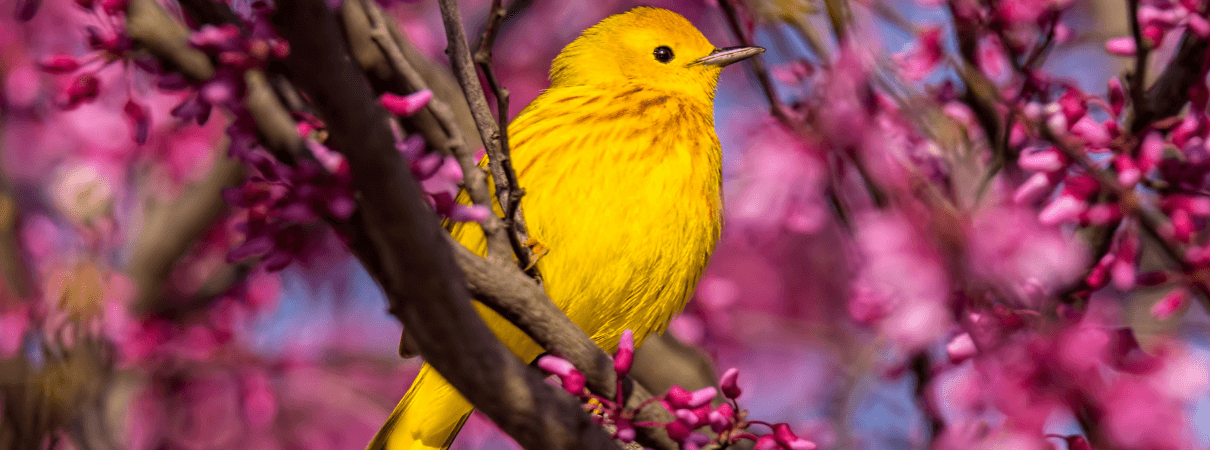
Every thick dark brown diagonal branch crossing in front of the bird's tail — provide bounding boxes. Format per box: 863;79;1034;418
273;0;616;449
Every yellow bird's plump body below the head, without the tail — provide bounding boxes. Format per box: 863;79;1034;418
454;85;721;358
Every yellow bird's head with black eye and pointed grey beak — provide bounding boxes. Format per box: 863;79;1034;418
551;7;765;99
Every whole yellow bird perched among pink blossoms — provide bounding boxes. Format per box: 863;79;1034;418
369;7;764;450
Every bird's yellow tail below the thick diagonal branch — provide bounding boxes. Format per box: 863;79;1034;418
367;363;474;450
